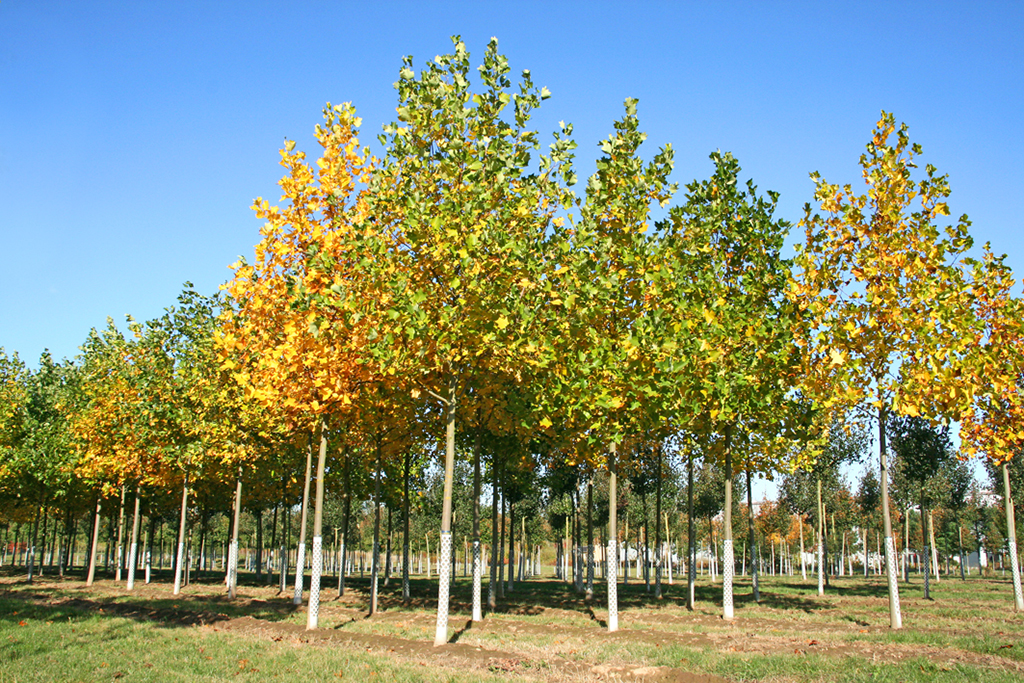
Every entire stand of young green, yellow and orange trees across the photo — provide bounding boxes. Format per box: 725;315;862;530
0;39;1024;644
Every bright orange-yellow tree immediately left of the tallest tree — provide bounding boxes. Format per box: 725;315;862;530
218;103;376;629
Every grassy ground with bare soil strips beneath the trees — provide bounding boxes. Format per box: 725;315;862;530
0;568;1024;683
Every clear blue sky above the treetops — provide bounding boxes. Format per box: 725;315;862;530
0;0;1011;491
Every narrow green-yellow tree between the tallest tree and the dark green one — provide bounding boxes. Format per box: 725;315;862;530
540;98;676;631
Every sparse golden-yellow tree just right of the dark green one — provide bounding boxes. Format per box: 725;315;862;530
793;112;972;629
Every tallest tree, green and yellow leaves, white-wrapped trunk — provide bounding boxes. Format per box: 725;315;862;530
336;38;573;644
